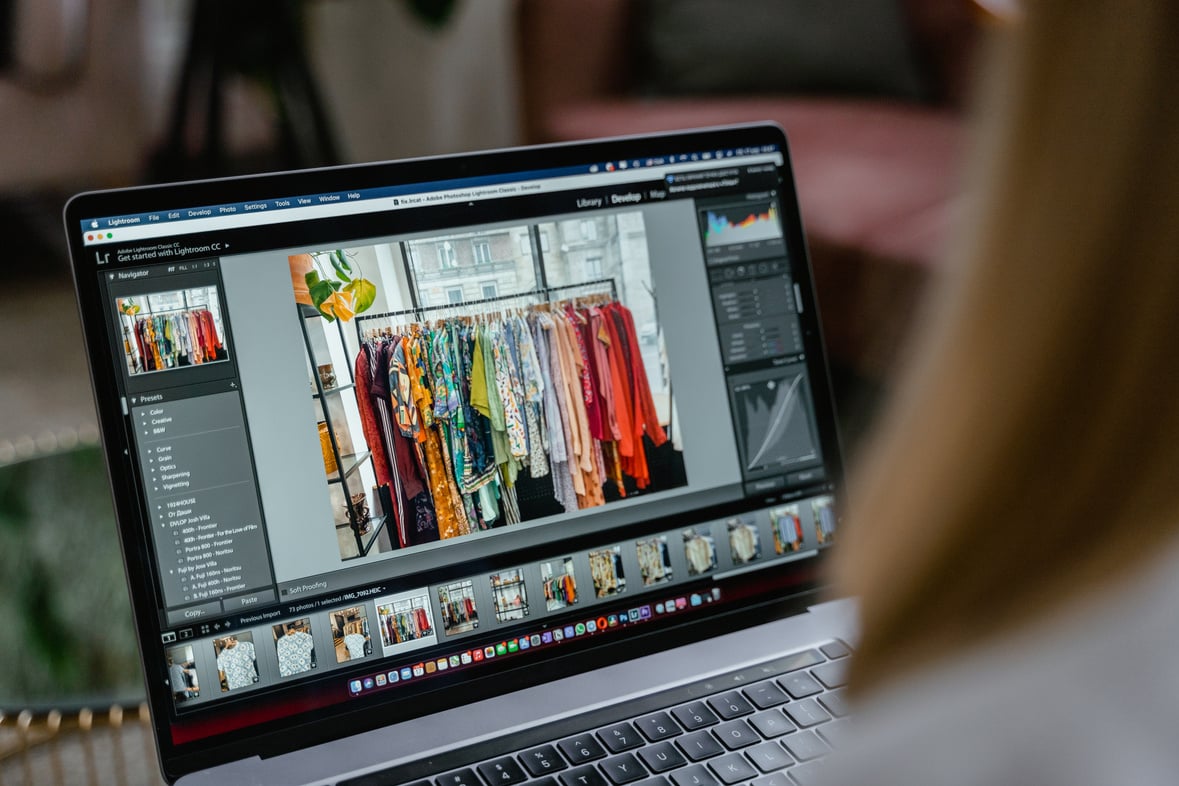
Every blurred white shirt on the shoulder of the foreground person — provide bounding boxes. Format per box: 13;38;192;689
825;546;1179;786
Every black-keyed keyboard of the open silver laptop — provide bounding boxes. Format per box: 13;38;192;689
340;640;850;786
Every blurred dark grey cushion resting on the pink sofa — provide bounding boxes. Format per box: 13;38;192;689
639;0;926;100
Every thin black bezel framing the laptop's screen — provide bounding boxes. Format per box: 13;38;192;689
64;124;843;780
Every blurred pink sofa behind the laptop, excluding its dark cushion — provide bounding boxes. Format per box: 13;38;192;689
518;0;982;381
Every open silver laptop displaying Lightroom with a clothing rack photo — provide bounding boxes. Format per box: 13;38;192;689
65;125;854;786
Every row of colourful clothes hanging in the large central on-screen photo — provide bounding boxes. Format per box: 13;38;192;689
344;278;667;558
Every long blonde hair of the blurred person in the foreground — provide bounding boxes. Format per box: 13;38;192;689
835;0;1179;692
